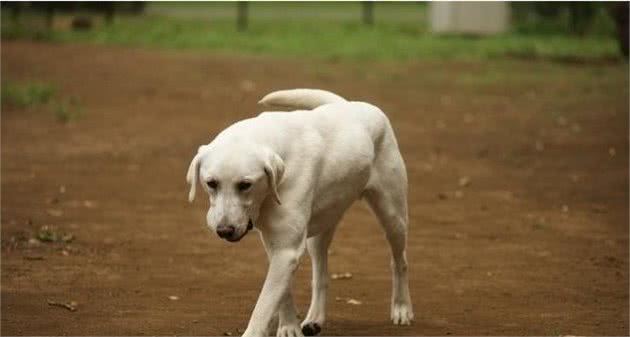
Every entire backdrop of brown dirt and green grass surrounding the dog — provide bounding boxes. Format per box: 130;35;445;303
0;1;629;336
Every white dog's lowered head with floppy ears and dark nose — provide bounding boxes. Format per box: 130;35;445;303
186;143;284;242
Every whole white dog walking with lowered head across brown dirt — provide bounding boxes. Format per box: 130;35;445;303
186;89;413;336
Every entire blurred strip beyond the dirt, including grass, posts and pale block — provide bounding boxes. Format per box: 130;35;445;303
2;1;628;60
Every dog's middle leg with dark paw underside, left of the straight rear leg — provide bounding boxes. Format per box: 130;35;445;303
302;224;337;336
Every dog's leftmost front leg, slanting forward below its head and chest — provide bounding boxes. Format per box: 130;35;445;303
243;243;304;336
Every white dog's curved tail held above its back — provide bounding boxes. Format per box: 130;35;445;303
258;89;347;110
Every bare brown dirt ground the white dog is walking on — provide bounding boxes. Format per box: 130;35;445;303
1;41;629;335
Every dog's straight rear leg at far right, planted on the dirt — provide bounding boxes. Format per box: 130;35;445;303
364;157;413;325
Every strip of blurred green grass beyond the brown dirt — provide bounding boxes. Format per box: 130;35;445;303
2;3;620;61
